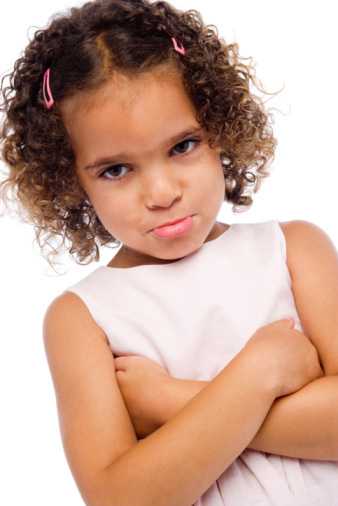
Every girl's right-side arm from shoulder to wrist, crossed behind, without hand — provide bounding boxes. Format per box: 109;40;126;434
145;220;338;461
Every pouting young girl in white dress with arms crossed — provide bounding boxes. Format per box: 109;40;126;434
1;0;338;506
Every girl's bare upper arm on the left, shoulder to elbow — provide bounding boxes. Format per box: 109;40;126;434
43;292;138;504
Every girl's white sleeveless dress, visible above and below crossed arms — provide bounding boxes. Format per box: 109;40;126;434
66;220;338;506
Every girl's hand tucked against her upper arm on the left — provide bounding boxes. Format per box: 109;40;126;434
114;355;170;438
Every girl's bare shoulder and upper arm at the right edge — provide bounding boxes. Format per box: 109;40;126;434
280;220;338;375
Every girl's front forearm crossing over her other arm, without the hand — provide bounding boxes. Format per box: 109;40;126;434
101;352;280;506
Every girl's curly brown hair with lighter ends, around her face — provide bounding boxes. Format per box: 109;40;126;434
0;0;277;270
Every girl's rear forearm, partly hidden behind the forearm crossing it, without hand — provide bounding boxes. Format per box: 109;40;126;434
161;376;338;460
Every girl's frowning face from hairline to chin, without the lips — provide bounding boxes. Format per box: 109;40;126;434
61;69;225;263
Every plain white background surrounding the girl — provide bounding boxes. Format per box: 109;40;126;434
0;0;338;506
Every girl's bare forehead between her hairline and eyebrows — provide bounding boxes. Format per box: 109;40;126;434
61;68;197;162
